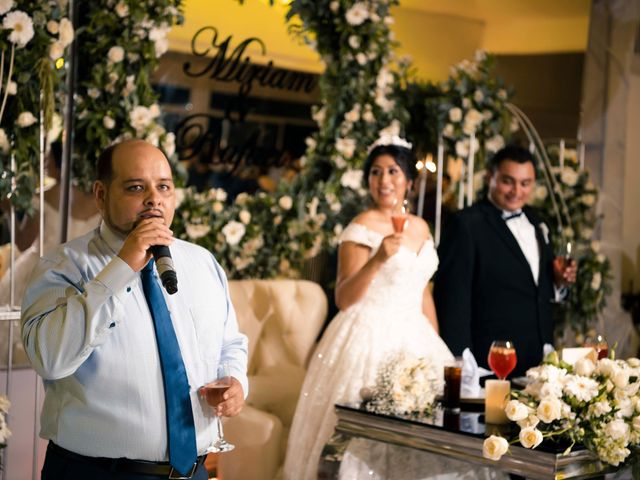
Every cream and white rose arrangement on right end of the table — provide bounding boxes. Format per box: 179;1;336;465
483;352;640;466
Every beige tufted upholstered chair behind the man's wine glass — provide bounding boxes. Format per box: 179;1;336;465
219;280;327;480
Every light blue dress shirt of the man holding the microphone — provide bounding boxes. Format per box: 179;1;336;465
22;223;248;461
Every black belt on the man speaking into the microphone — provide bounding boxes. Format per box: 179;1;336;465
47;442;206;480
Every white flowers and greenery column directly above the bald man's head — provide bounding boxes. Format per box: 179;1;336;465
73;0;183;191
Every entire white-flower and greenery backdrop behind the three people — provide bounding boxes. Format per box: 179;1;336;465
0;0;610;340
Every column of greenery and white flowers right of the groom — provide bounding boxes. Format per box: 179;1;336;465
533;147;612;338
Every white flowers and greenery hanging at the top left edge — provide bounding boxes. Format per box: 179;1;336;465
0;0;75;212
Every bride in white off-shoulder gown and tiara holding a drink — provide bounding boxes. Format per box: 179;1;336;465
284;137;504;480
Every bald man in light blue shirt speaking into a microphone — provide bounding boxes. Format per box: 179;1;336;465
22;140;248;480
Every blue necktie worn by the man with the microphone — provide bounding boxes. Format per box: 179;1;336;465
142;260;197;475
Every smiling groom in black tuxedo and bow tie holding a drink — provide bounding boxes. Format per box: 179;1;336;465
434;146;576;376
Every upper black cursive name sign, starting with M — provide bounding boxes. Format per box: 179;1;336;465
183;27;317;97
